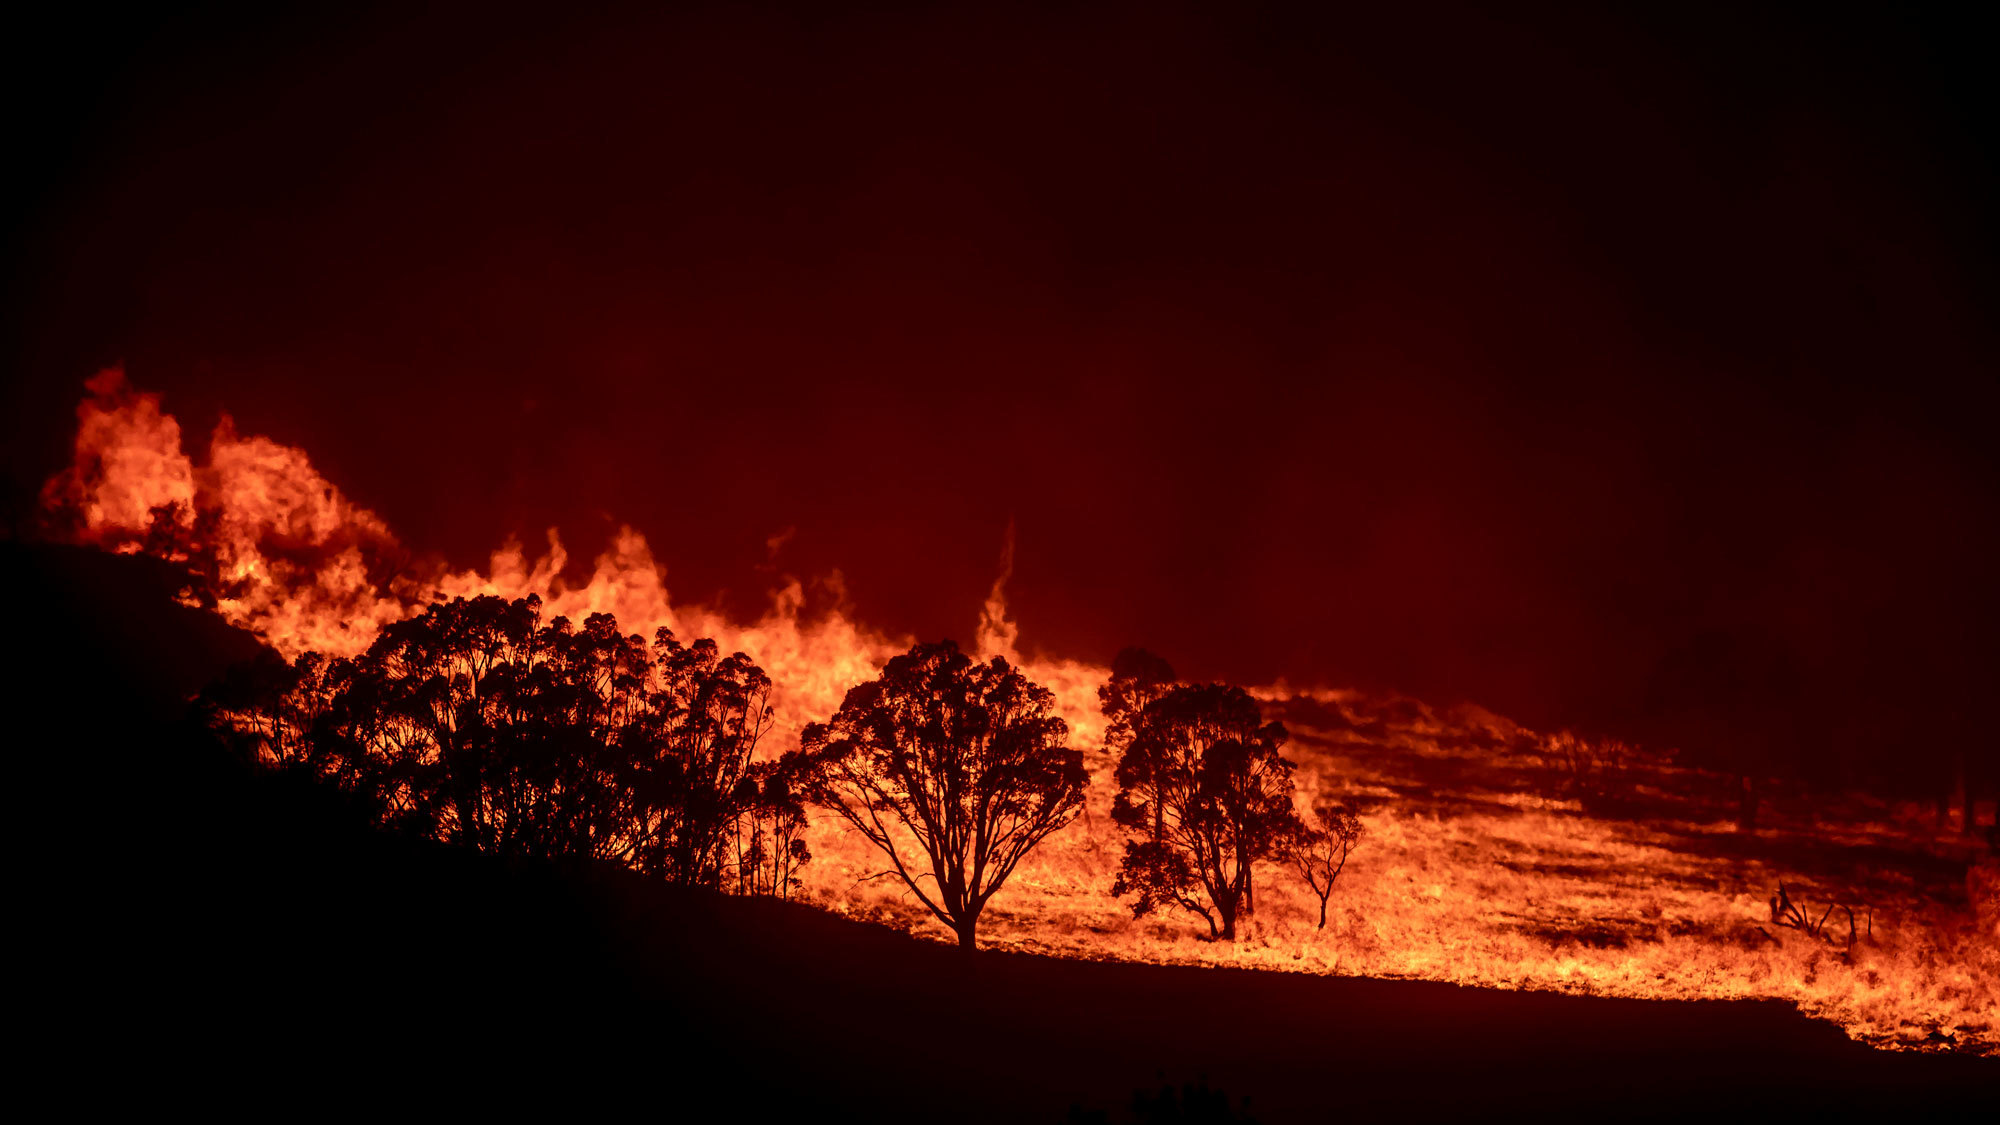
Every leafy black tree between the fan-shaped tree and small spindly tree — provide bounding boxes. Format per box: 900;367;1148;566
1112;685;1296;939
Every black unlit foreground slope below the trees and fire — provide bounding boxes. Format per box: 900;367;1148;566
15;542;2000;1123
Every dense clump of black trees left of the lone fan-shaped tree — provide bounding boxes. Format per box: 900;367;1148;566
208;597;788;887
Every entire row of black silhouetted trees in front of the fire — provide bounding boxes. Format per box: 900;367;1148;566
202;597;1360;949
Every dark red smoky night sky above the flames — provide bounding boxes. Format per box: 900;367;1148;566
4;4;2000;768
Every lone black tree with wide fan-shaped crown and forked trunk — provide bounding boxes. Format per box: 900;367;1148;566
804;641;1088;951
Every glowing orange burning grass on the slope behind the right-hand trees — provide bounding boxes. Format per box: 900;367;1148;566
810;693;2000;1053
